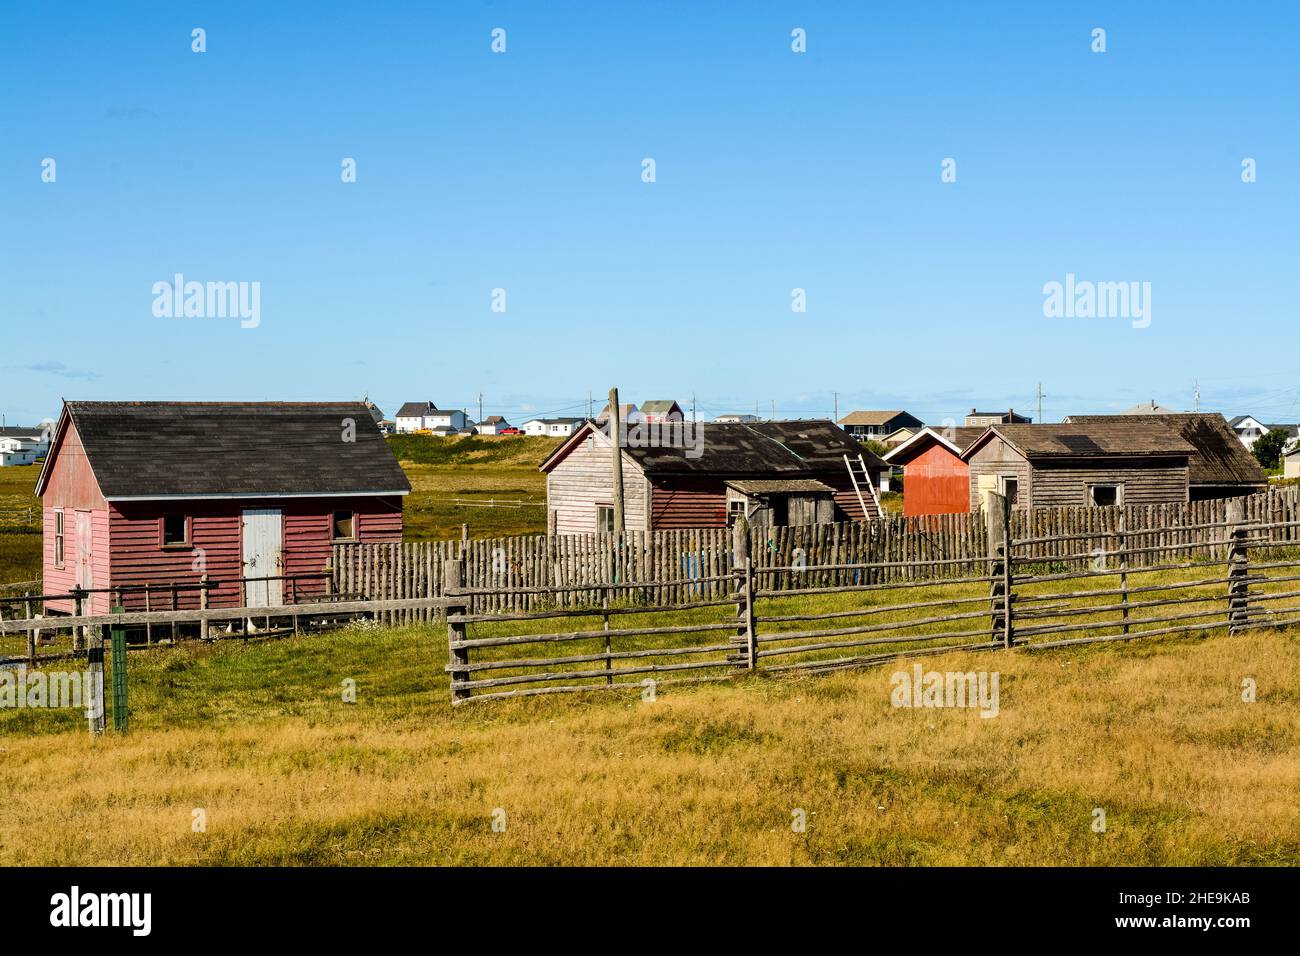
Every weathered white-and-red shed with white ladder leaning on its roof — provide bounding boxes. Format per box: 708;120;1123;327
541;421;888;533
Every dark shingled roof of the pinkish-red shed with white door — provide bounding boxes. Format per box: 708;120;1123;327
36;402;411;499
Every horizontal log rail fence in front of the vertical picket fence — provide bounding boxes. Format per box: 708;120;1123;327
442;494;1300;705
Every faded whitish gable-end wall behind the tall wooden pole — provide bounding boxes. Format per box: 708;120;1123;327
546;433;650;535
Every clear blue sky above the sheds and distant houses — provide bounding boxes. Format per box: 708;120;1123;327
0;3;1300;423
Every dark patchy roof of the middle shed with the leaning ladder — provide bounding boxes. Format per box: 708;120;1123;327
541;420;889;479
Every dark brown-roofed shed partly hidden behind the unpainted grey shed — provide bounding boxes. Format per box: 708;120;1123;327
1066;412;1269;501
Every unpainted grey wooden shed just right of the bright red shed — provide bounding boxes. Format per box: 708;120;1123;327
962;416;1196;511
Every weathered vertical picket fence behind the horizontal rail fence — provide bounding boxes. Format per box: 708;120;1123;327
332;488;1300;623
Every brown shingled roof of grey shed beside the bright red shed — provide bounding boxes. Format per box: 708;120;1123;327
962;415;1195;462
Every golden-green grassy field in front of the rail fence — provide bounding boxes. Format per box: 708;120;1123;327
0;616;1300;865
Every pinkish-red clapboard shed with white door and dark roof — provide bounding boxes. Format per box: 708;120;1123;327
36;402;411;613
